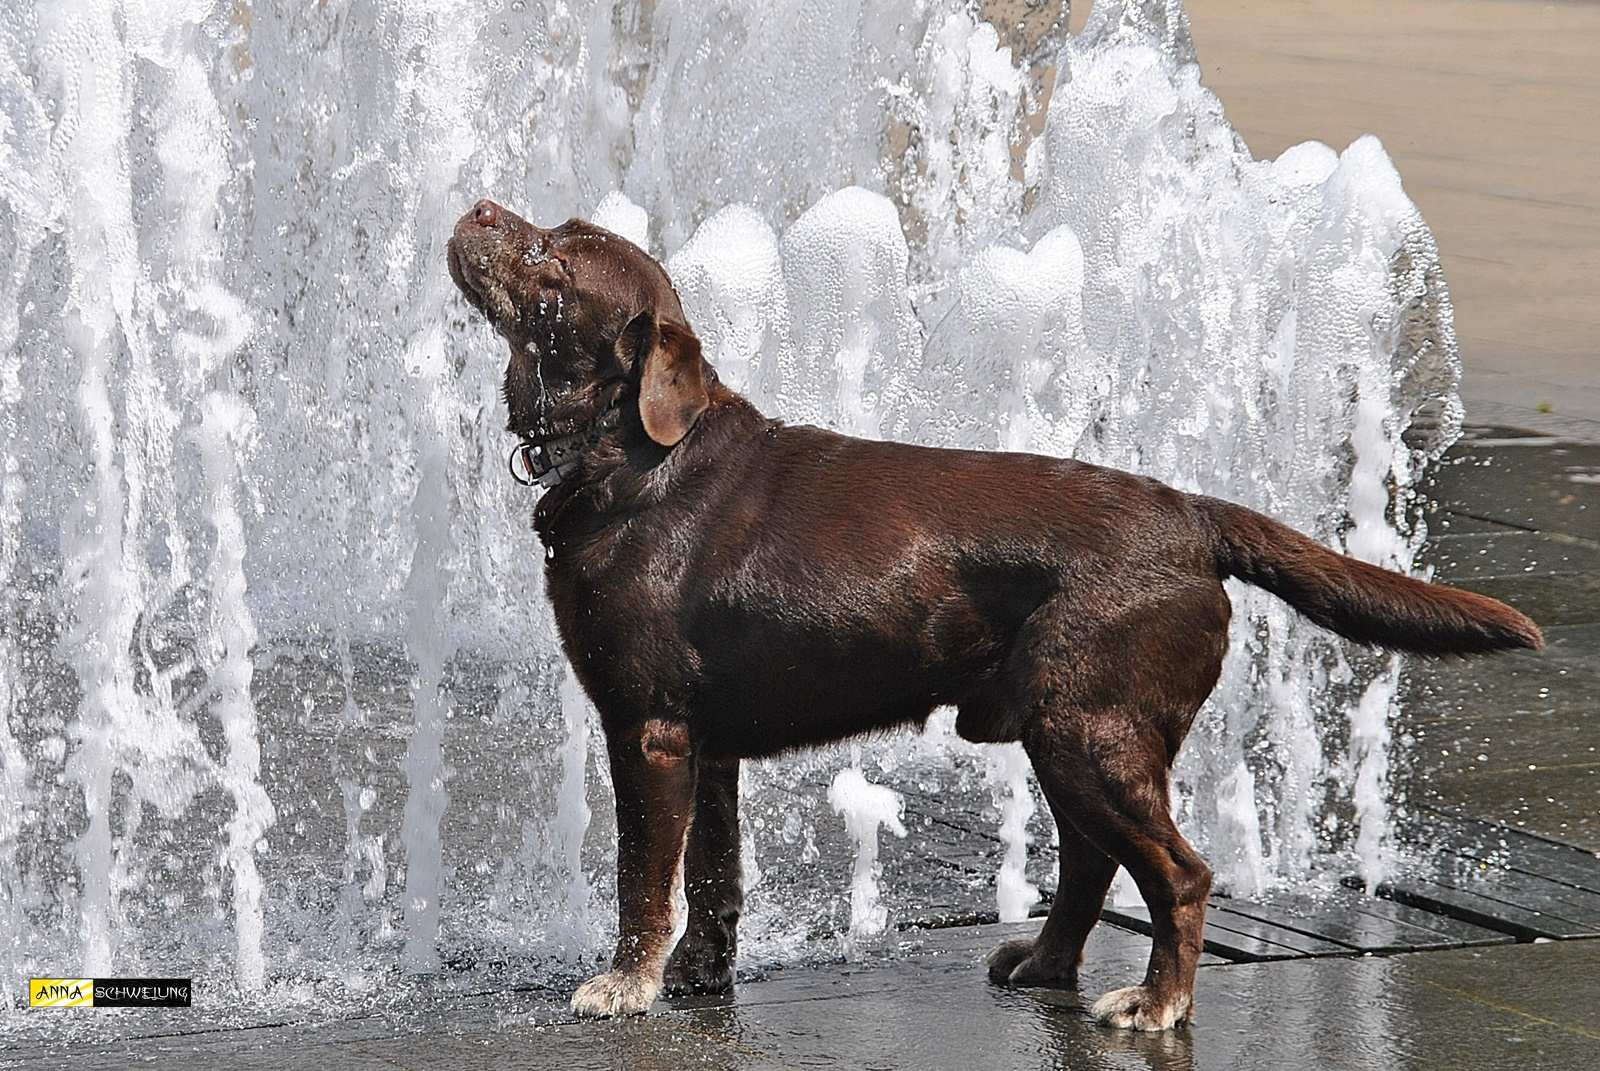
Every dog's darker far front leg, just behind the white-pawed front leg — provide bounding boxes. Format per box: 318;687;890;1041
666;757;744;993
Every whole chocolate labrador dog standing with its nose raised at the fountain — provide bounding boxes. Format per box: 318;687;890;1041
450;200;1542;1029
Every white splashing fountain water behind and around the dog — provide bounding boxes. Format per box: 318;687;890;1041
0;0;1459;1023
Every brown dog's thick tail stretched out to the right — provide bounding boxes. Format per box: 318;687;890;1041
1195;496;1544;655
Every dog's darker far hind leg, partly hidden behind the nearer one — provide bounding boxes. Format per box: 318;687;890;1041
989;813;1117;989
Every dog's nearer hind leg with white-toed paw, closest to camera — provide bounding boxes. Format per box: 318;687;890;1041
1024;711;1211;1029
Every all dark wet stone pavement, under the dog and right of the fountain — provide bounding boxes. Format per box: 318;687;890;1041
12;429;1600;1071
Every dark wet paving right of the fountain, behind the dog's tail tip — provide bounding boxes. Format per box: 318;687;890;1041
1403;429;1600;852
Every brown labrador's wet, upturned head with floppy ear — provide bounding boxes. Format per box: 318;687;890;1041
448;200;714;447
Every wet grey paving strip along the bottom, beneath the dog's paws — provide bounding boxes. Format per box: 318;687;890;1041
18;924;1600;1071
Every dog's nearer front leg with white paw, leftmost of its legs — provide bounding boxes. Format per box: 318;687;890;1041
573;717;694;1018
